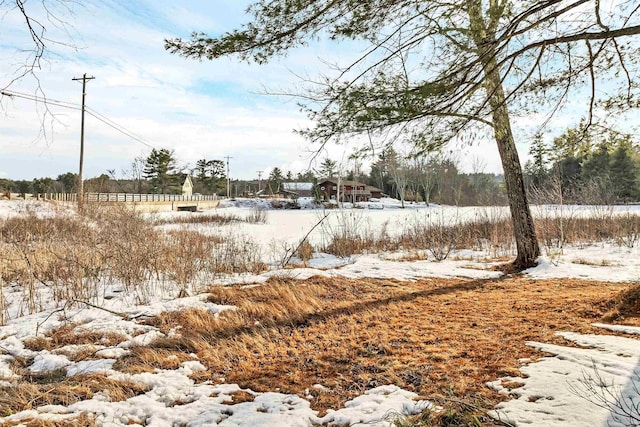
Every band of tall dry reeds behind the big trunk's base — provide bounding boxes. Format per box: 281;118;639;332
321;206;640;261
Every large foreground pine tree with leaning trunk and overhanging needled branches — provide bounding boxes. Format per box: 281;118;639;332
165;0;640;268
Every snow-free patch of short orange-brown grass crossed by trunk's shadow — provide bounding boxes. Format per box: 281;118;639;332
124;277;640;416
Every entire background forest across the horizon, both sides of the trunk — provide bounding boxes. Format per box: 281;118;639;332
5;122;640;206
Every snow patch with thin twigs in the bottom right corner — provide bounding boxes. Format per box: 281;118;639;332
489;325;640;427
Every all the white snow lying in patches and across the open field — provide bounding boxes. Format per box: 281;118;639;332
0;202;640;426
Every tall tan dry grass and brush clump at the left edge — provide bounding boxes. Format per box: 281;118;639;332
0;205;265;324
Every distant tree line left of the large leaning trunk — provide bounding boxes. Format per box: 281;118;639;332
0;147;506;206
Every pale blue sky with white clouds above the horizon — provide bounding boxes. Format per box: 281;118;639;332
0;0;636;179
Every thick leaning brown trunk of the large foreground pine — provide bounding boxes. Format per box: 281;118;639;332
467;0;540;269
